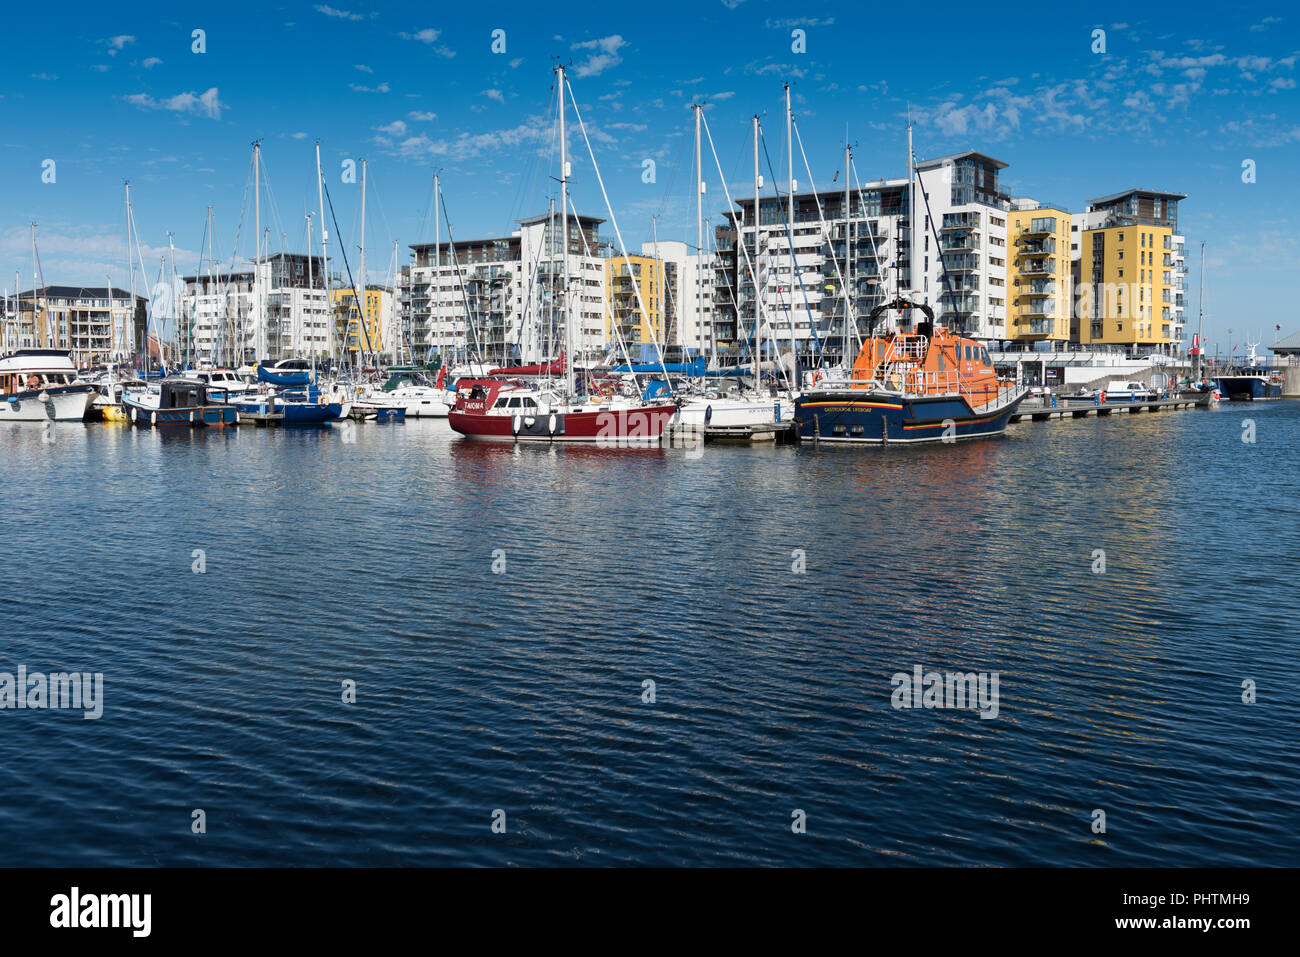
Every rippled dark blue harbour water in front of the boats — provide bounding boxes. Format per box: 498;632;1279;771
0;402;1300;865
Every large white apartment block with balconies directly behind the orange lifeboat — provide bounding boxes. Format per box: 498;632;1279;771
715;151;1009;361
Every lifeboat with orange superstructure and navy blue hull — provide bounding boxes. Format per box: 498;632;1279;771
794;299;1027;445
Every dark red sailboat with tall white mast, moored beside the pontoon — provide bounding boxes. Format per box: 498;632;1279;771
447;65;677;446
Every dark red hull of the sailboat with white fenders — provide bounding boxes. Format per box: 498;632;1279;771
447;404;677;445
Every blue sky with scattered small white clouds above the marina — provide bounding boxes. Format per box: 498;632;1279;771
0;0;1300;342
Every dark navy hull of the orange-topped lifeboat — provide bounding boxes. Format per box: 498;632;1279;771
794;390;1024;445
